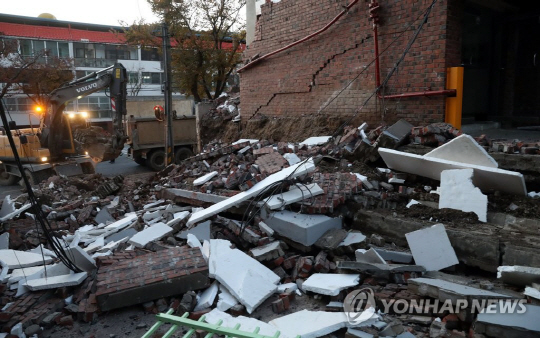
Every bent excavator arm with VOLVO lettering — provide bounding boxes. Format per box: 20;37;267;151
41;63;127;160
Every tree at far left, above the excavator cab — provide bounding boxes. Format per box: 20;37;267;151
0;33;73;106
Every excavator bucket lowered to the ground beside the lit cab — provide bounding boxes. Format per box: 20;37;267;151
73;126;123;162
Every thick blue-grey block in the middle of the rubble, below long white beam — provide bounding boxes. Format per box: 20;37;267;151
263;211;342;246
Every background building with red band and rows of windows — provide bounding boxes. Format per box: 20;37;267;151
0;14;193;129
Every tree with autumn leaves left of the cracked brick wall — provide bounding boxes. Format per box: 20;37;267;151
124;0;245;102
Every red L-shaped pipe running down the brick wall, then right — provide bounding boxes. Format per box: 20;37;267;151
369;0;456;99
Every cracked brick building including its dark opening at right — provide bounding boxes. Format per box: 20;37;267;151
240;0;540;126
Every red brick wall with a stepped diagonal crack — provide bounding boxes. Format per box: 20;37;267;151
240;0;460;126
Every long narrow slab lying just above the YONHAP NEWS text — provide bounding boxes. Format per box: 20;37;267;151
407;278;511;300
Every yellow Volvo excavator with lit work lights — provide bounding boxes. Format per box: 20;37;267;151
0;63;128;185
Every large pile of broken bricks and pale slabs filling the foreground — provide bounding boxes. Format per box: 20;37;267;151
0;120;540;338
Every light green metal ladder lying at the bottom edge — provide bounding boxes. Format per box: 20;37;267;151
142;309;300;338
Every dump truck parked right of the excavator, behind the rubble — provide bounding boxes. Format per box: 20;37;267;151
126;116;197;171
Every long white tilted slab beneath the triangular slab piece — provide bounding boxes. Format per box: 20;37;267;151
379;148;527;196
